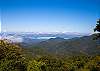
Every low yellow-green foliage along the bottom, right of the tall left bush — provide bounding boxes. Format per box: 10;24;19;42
27;56;100;71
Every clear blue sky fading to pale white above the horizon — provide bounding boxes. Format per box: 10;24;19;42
0;0;100;33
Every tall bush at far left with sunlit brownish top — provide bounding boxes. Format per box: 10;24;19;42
0;40;25;71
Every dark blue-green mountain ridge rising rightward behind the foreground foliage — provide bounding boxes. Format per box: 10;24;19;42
22;35;100;56
